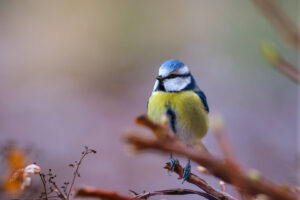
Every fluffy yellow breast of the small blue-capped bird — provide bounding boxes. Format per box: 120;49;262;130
148;91;209;143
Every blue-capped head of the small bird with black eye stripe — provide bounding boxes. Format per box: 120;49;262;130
153;59;195;92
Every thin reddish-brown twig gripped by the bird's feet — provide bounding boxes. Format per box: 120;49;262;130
164;163;236;200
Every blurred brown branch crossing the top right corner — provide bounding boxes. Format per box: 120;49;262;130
253;0;300;48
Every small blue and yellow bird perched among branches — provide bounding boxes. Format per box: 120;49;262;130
147;59;209;183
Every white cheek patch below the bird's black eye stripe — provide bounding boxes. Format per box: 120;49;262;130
164;76;192;92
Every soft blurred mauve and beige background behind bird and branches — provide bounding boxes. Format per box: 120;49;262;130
0;0;299;199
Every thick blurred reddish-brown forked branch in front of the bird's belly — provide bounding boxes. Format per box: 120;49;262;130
125;116;299;200
